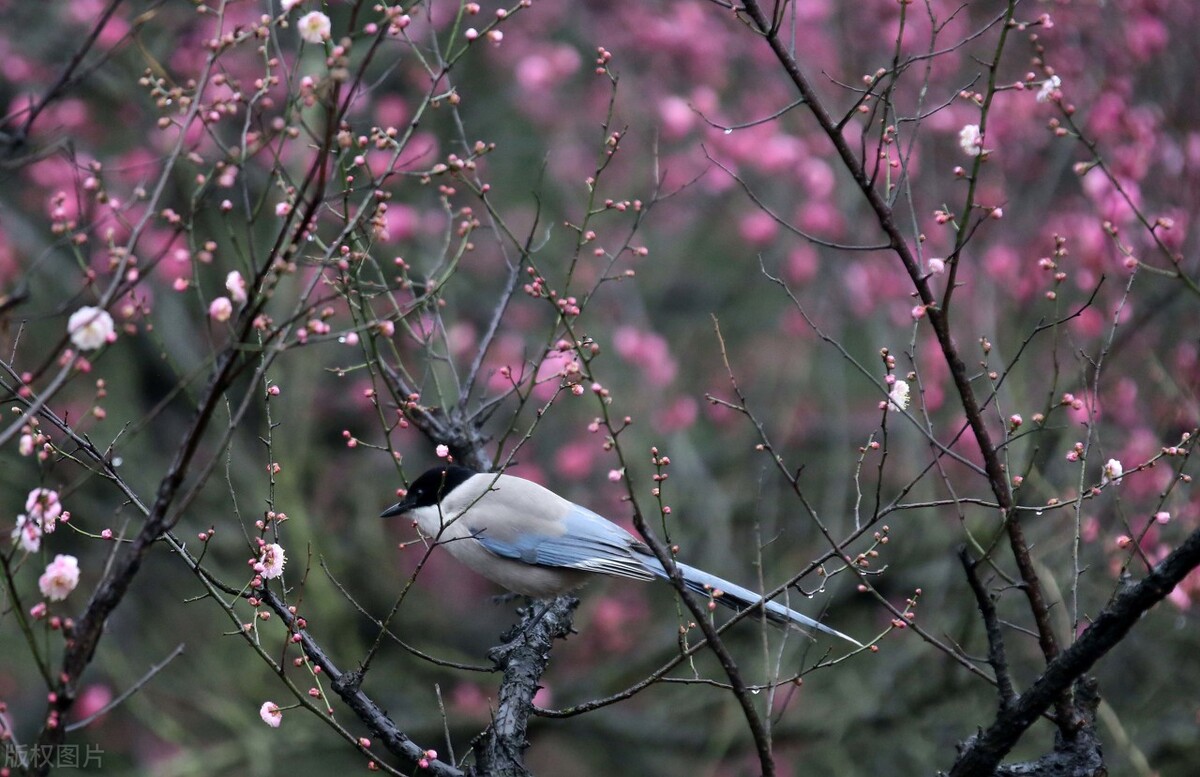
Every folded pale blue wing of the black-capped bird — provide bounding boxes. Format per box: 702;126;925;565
474;505;655;580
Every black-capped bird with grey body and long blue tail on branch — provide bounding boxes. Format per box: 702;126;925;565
380;464;863;648
